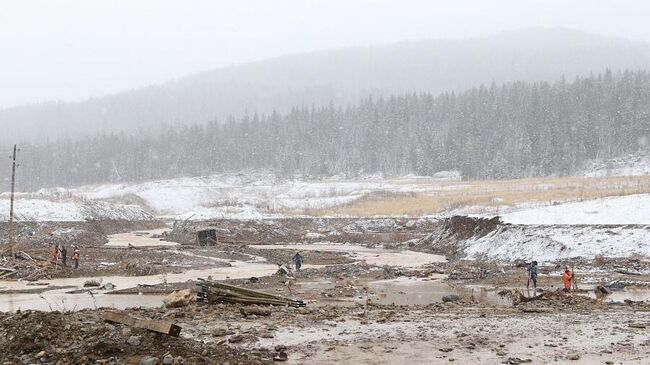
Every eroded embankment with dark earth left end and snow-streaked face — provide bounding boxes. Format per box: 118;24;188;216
409;216;650;261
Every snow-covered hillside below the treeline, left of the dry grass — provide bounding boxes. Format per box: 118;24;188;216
71;172;460;219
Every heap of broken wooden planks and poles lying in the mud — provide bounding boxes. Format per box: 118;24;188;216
196;279;306;308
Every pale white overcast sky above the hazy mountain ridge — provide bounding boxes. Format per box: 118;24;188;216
0;0;650;108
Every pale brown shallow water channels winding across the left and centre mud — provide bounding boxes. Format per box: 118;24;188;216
0;230;445;312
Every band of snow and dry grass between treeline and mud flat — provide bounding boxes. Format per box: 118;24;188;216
0;166;650;224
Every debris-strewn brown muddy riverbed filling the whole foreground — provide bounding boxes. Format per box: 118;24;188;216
0;222;650;364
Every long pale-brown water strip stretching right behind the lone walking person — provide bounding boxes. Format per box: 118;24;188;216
251;244;447;268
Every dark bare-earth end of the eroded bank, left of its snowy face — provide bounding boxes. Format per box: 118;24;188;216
409;216;503;258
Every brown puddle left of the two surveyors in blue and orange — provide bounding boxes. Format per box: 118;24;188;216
368;277;512;306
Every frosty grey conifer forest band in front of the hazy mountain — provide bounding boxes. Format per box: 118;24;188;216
0;71;650;190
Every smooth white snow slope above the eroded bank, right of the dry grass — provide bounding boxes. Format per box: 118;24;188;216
502;194;650;224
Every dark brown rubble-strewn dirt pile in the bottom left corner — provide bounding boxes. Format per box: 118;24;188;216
0;311;273;364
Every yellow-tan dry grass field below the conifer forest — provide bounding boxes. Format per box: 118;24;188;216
284;176;650;216
